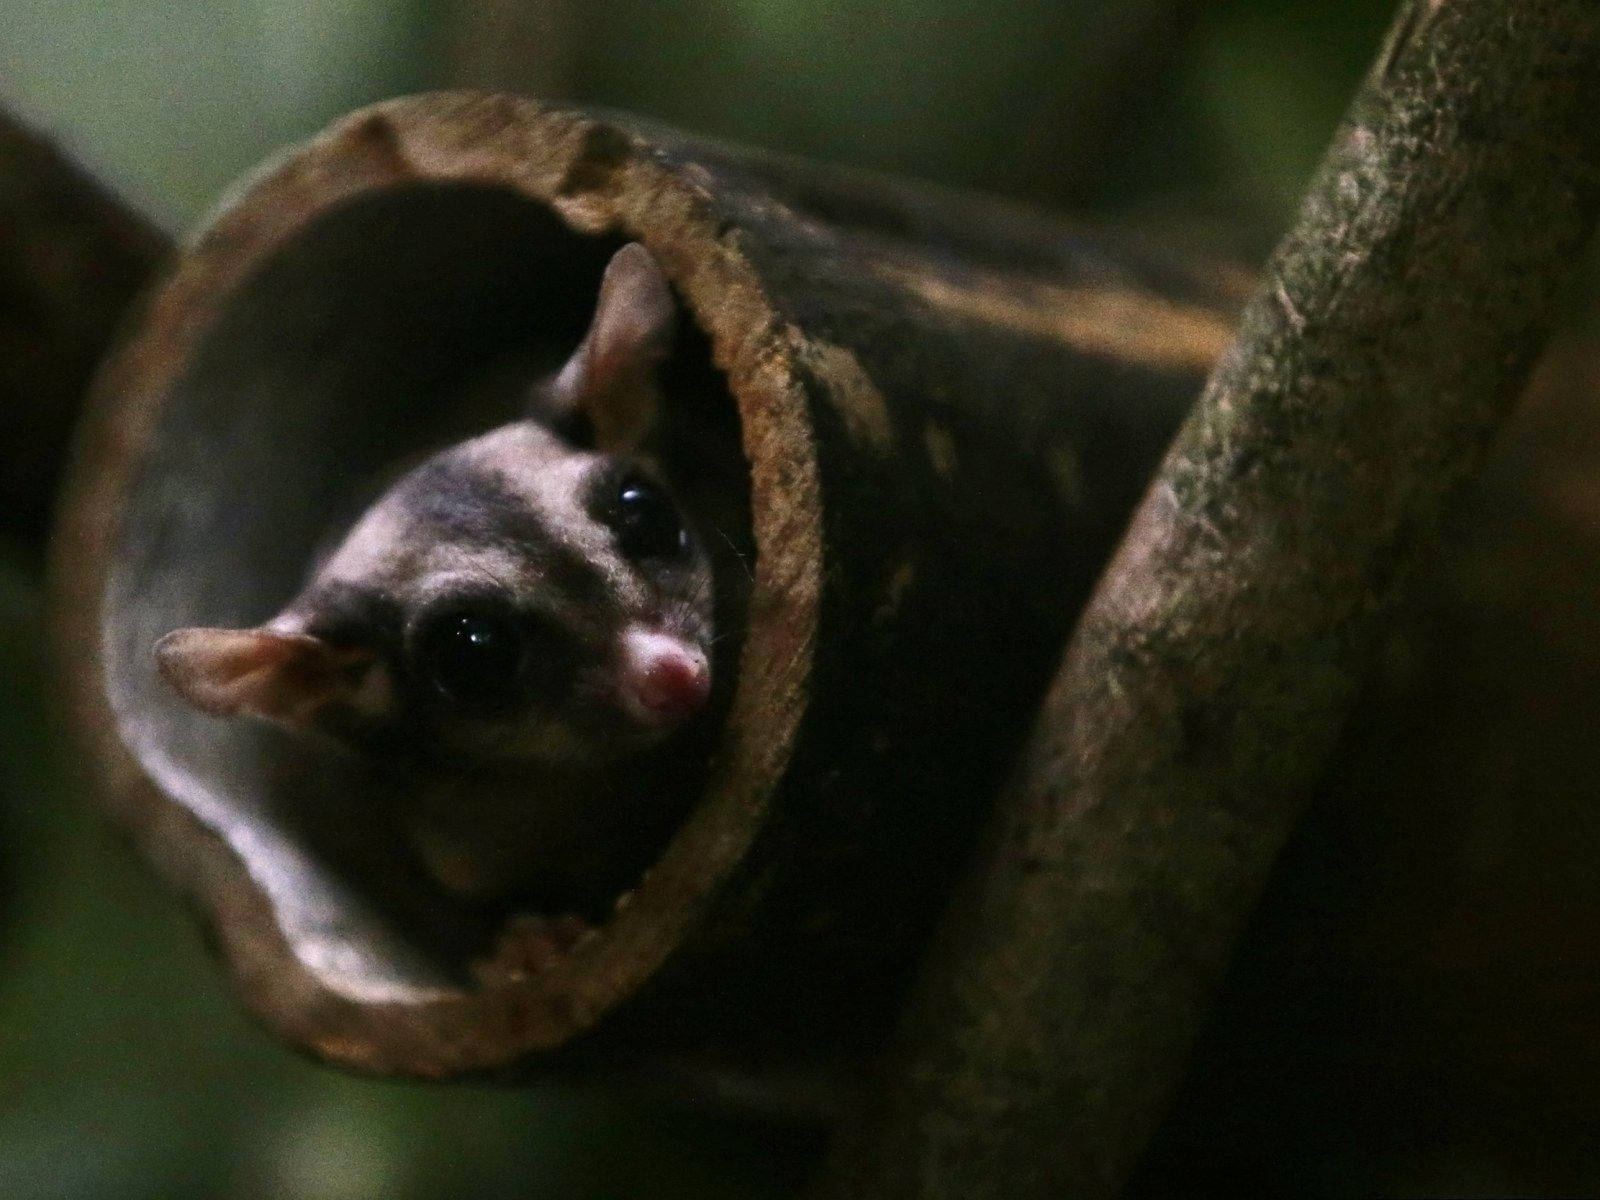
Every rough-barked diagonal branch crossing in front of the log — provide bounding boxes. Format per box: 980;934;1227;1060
824;0;1600;1200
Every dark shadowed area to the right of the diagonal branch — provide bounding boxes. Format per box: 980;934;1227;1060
1128;336;1600;1200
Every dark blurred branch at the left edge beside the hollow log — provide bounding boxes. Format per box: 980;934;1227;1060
0;110;170;550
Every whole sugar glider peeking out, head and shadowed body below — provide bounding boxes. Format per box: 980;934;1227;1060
155;243;747;909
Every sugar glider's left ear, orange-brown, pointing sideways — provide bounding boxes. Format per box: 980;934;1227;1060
155;627;371;726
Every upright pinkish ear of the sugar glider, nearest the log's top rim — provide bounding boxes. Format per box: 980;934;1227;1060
544;242;678;451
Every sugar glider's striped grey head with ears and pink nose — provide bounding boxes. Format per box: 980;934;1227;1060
155;243;712;768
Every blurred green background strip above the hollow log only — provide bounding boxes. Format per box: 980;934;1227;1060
0;0;1394;234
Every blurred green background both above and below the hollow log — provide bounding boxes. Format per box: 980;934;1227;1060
0;0;1427;1200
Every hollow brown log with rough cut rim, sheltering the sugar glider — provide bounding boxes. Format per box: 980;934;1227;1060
53;93;1242;1104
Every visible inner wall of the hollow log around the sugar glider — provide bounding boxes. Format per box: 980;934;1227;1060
104;178;731;1002
